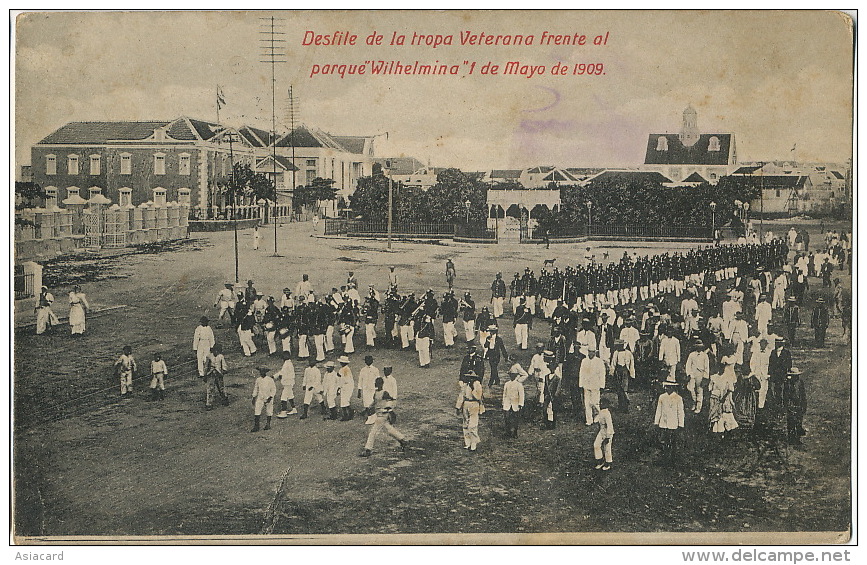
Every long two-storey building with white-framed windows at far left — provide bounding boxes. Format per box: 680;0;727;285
31;117;256;207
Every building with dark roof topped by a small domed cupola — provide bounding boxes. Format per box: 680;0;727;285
642;106;738;184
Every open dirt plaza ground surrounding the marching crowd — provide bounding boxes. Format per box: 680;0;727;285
14;219;851;542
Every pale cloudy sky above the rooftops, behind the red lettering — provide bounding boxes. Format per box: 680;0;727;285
15;11;853;170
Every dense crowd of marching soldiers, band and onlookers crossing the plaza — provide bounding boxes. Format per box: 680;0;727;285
139;240;845;458
